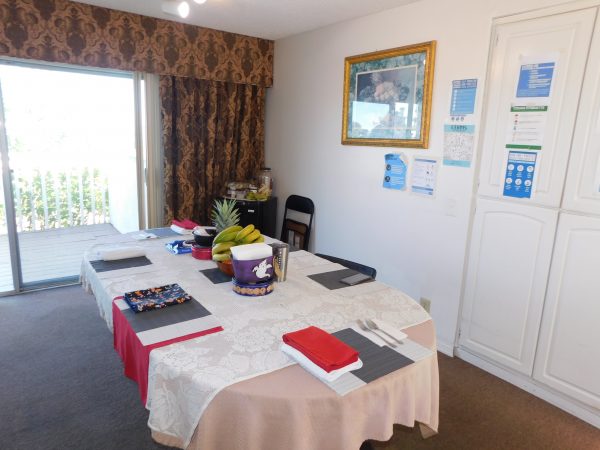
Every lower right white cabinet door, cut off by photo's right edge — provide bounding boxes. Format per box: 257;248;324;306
534;214;600;408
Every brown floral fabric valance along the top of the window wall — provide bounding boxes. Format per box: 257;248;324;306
0;0;273;87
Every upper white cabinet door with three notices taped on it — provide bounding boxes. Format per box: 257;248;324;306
479;8;596;207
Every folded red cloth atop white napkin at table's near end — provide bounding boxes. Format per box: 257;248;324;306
283;326;358;372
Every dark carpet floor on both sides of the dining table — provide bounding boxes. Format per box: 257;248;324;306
0;286;600;450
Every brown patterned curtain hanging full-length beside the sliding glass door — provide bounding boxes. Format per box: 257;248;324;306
160;76;265;225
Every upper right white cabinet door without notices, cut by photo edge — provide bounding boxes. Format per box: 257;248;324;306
563;17;600;214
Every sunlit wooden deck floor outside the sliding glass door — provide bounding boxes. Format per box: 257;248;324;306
0;224;119;292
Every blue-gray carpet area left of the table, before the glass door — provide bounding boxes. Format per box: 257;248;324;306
0;286;173;450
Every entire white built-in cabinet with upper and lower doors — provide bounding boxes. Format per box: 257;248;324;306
459;8;600;409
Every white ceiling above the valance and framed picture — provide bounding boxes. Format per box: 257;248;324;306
77;0;417;39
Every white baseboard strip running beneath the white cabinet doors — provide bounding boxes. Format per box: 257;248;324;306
454;347;600;428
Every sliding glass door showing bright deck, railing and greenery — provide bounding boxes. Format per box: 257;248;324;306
0;61;143;292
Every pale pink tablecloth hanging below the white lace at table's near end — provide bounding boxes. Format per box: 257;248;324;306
152;321;439;450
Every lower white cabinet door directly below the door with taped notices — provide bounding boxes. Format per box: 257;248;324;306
460;199;558;375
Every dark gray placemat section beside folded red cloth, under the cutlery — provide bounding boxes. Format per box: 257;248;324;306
332;328;414;383
